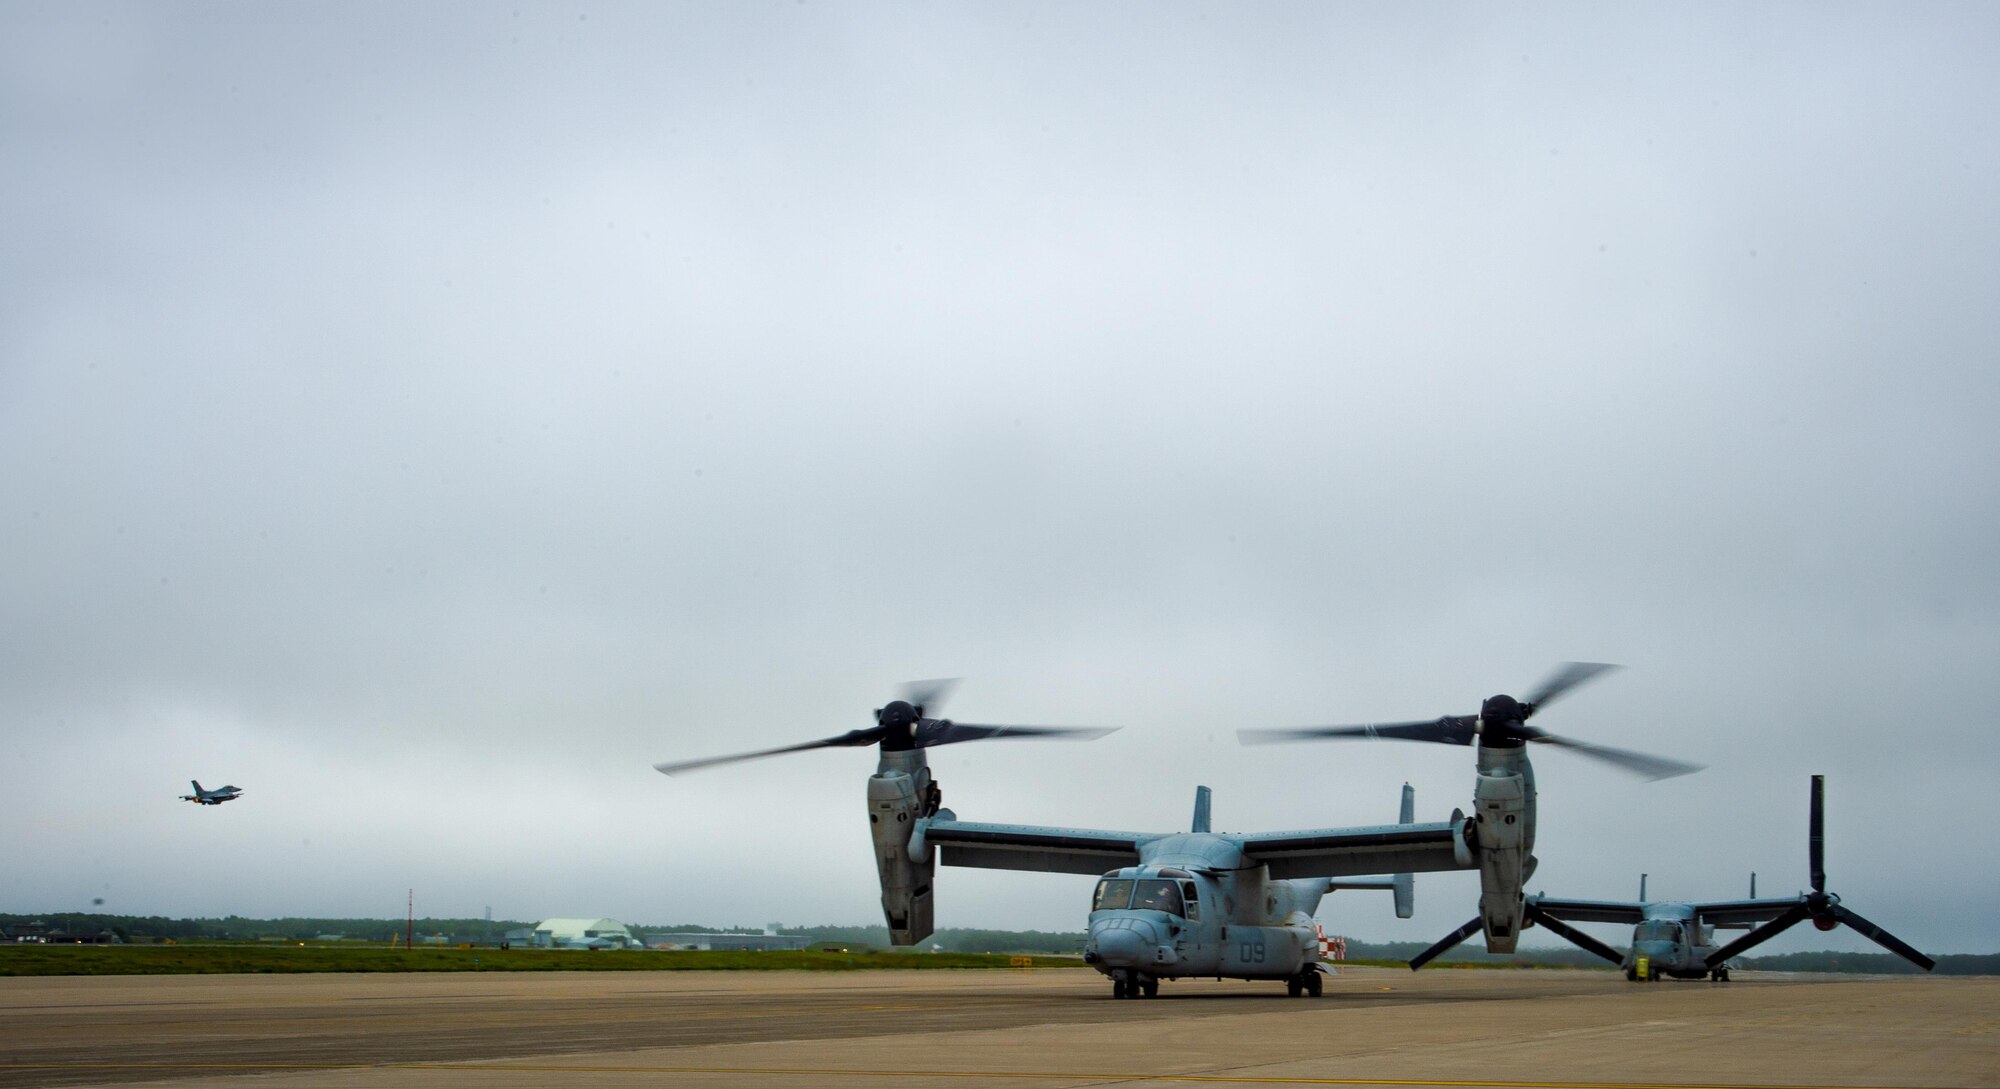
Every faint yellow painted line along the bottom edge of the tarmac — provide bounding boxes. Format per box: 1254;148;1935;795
0;1061;1952;1089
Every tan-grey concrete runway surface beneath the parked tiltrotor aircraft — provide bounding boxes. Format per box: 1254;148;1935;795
0;969;2000;1089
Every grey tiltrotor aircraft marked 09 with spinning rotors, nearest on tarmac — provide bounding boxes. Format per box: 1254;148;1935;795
654;667;1694;999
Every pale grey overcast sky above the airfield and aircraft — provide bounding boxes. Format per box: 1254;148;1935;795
0;0;2000;953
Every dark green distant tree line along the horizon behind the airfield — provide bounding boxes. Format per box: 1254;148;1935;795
0;911;2000;975
